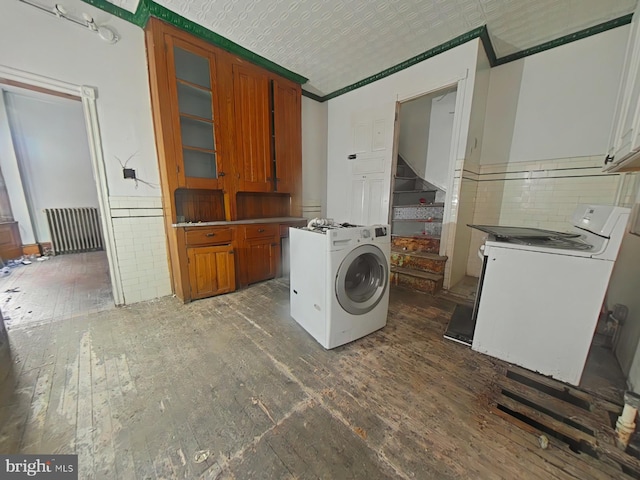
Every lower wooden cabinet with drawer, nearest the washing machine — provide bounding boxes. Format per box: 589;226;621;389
241;224;280;285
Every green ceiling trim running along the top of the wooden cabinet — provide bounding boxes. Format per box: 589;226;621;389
145;0;308;84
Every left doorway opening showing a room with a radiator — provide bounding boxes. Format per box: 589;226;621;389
0;83;115;327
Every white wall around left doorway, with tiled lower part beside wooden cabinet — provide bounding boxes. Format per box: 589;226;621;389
0;0;171;303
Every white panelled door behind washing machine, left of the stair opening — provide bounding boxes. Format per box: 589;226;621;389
348;111;393;225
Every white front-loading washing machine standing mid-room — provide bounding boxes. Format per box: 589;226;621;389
289;221;391;349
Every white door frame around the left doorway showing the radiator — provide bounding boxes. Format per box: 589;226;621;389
0;65;124;305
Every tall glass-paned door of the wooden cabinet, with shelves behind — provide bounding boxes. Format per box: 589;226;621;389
167;38;224;187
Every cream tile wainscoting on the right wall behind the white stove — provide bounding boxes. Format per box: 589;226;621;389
464;155;622;277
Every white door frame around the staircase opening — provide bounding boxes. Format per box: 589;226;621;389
389;71;468;264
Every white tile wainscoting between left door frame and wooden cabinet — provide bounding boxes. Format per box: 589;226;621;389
109;196;171;304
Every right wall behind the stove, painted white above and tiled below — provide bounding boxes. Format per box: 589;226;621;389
467;26;629;276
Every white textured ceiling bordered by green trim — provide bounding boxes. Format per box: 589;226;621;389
152;0;636;94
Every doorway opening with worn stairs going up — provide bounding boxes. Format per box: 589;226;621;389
390;85;458;293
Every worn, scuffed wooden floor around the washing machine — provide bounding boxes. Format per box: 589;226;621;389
0;280;627;479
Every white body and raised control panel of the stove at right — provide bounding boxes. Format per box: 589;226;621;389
472;205;629;385
